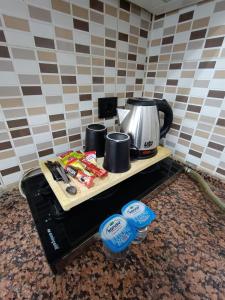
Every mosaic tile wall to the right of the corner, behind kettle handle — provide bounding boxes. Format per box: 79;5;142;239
144;1;225;179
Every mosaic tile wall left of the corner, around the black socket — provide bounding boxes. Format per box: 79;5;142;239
0;0;151;185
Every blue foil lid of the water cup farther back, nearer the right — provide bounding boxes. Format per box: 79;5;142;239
121;200;156;228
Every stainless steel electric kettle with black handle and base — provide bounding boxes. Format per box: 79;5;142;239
117;98;173;159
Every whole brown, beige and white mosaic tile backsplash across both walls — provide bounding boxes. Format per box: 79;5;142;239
0;0;225;186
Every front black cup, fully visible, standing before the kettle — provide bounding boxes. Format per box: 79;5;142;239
103;132;130;173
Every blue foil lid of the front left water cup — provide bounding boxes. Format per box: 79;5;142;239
99;214;135;253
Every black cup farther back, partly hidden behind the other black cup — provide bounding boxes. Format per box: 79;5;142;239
85;124;107;157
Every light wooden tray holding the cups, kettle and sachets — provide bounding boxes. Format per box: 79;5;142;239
39;146;171;210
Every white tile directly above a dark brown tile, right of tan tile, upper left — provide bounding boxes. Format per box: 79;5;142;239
30;21;55;39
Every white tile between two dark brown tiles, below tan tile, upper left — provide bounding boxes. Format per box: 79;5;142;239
5;29;34;47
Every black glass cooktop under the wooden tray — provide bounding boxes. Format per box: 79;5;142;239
23;158;182;266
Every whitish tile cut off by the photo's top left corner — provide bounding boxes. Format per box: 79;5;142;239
0;0;29;19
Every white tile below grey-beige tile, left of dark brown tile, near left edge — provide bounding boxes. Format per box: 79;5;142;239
13;59;40;74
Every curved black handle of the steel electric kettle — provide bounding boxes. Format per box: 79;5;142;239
154;99;173;139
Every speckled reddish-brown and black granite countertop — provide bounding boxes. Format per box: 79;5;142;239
0;174;225;300
